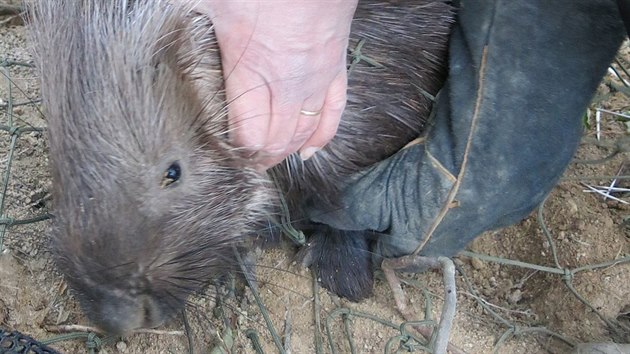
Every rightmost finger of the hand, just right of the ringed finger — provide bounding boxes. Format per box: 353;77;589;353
300;70;348;160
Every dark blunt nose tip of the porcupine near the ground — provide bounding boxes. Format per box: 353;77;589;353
92;295;164;335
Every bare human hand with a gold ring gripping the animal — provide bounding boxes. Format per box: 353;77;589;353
190;0;358;170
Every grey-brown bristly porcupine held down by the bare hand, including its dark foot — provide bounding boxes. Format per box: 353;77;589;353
31;0;453;333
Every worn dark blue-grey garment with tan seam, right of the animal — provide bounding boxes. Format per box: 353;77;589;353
309;0;625;257
